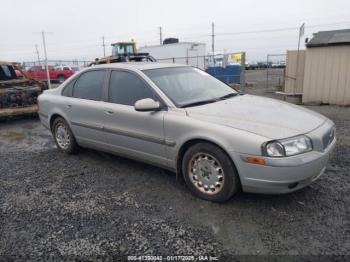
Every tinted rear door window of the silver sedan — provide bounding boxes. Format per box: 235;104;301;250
73;70;105;101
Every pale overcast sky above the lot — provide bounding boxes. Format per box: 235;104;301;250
0;0;350;61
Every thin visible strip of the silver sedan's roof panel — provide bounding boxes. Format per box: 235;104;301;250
92;62;187;70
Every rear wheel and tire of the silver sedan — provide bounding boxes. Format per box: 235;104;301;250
52;117;78;154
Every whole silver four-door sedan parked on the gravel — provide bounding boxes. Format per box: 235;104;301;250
38;63;336;201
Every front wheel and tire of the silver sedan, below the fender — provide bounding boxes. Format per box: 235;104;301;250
182;142;240;202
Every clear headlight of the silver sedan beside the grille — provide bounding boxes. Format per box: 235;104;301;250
262;135;312;157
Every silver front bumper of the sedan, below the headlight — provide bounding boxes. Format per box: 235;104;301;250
230;122;336;194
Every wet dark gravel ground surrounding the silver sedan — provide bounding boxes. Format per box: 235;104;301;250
0;70;350;261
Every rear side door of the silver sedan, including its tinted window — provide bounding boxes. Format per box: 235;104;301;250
62;69;106;146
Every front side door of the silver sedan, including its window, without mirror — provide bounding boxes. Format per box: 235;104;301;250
104;70;165;164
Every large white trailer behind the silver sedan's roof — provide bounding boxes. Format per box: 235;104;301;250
138;42;206;70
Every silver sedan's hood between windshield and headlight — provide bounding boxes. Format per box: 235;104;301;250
186;95;327;139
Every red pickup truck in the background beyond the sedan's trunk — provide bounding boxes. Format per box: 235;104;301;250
27;65;74;83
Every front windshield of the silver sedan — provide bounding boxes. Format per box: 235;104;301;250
143;67;237;107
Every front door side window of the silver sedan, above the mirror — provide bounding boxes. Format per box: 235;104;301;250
109;71;154;106
